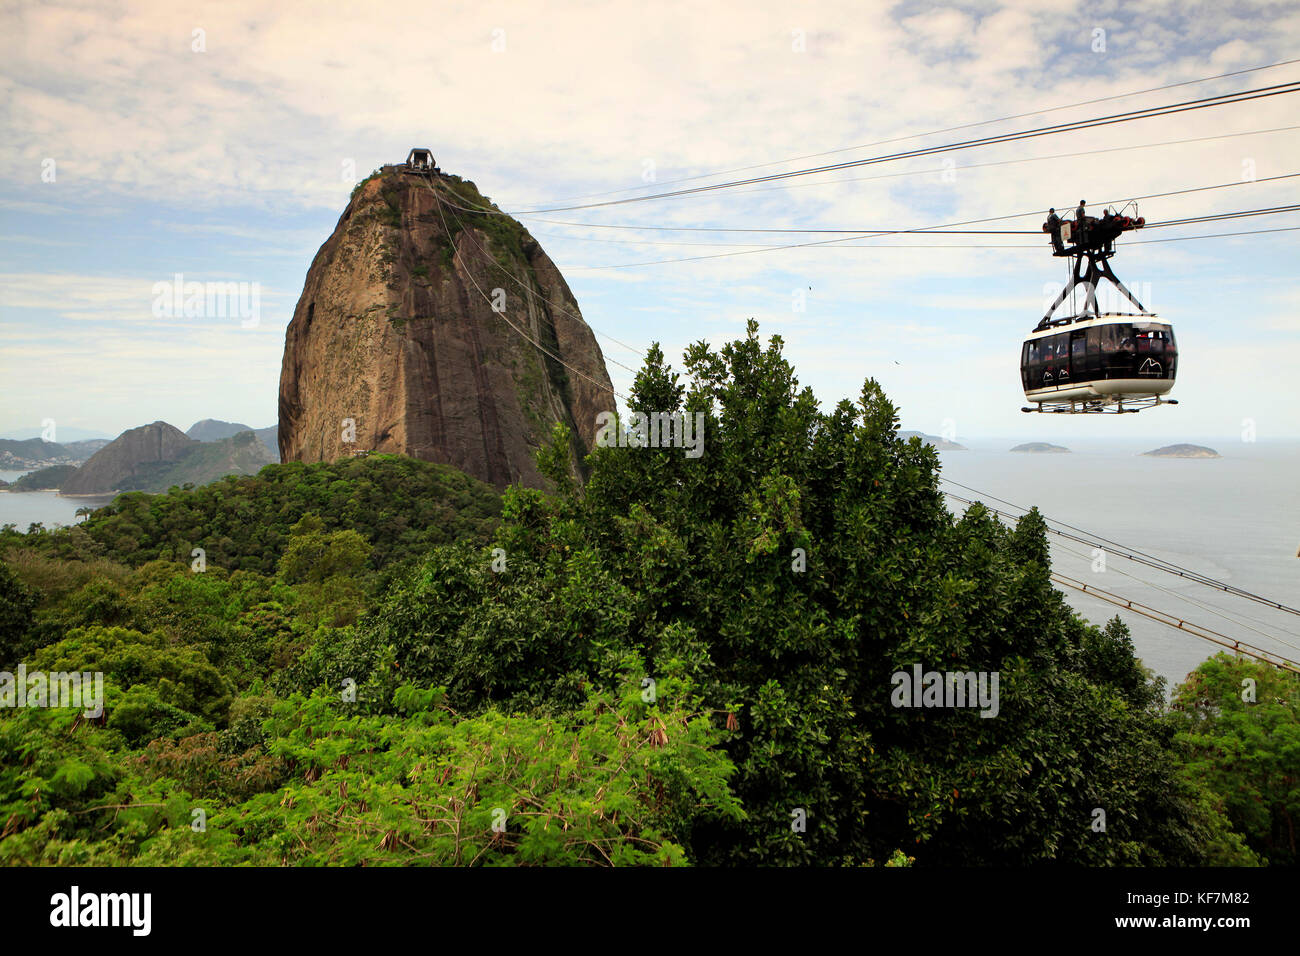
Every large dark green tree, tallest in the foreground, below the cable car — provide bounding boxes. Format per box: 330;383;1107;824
327;324;1226;865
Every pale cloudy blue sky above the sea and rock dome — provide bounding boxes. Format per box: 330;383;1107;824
0;0;1300;444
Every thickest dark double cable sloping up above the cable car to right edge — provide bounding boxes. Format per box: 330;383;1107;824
511;81;1300;215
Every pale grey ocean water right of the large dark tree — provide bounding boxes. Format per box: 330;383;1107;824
940;438;1300;689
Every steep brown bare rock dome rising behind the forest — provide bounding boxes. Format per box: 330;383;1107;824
280;166;614;489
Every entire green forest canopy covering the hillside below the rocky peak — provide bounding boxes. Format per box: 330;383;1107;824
0;325;1279;865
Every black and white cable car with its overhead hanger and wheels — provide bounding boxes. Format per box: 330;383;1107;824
1021;202;1178;414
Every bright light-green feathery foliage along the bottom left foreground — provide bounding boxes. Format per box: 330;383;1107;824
0;685;742;865
